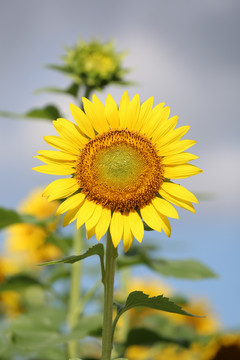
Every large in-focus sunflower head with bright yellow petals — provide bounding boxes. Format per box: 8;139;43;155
33;92;202;251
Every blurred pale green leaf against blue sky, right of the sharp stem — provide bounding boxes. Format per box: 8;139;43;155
151;259;217;280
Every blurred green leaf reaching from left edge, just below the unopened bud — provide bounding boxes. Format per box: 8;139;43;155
0;104;62;120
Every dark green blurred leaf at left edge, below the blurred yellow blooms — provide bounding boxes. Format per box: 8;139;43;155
0;274;44;292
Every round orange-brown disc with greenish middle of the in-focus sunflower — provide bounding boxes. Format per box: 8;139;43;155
75;130;163;213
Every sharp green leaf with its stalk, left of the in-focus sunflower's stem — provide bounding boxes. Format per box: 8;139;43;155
38;244;104;277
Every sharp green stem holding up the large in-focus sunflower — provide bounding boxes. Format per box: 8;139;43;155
102;230;117;360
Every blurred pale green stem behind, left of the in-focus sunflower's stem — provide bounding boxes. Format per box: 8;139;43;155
68;227;83;358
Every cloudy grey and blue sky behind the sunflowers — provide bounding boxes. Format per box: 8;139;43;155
0;0;240;329
